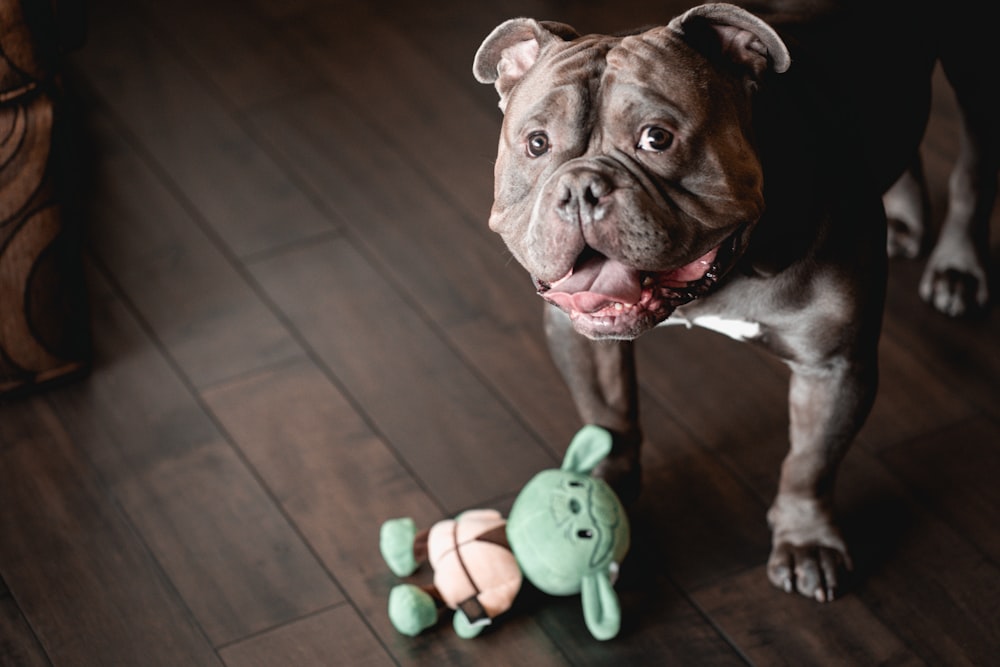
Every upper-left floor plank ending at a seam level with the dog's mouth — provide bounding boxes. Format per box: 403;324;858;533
72;0;334;257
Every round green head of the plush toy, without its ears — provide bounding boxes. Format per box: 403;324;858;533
507;470;629;595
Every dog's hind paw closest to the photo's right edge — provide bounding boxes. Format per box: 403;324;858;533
920;236;990;317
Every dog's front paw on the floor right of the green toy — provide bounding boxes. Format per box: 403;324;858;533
767;499;852;602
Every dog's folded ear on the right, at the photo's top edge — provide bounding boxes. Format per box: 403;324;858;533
668;2;792;80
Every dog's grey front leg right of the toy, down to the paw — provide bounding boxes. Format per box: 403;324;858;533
767;358;877;602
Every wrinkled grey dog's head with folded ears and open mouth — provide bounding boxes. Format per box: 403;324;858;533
474;4;789;339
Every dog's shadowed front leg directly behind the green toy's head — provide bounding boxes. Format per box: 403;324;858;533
545;306;642;503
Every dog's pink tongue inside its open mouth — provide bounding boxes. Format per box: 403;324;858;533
545;255;642;313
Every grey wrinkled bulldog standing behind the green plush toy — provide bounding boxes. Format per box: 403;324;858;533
473;2;1000;602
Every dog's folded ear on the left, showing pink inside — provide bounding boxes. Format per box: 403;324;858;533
472;18;579;109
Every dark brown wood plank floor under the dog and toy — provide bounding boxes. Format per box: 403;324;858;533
0;0;1000;667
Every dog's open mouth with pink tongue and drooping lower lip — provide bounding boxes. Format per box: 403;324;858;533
534;227;743;339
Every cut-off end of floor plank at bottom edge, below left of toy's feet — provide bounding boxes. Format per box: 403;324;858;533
219;605;395;667
